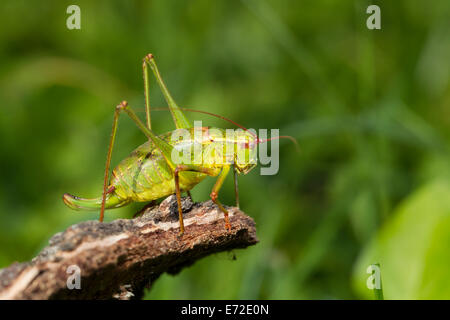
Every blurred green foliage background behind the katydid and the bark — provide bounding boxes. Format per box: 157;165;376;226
0;0;450;299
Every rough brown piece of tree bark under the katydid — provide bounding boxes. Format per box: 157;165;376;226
0;196;258;299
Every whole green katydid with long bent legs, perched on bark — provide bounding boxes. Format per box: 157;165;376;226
63;54;284;235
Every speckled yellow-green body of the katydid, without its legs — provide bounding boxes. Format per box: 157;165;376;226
64;127;256;210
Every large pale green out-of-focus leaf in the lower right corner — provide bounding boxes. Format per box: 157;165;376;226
354;180;450;299
